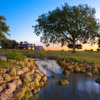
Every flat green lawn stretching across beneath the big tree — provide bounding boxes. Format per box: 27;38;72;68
0;49;100;63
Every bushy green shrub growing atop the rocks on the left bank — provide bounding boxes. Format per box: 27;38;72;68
5;50;25;61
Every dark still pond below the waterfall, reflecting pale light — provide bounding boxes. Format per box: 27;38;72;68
37;73;100;100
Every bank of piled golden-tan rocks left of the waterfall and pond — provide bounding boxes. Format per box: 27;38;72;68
0;57;47;100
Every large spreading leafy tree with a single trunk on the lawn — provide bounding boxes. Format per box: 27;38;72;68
33;4;100;52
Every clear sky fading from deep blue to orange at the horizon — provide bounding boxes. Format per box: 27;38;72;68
0;0;100;50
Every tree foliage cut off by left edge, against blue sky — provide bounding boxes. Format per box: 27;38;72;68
0;16;10;40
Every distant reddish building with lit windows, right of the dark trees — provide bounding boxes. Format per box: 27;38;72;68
19;41;35;50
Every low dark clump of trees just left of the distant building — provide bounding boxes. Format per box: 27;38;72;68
1;39;18;49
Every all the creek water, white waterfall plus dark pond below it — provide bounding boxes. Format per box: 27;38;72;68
30;59;100;100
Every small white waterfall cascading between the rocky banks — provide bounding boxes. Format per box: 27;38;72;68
34;59;62;76
